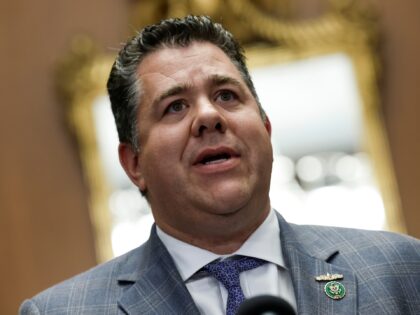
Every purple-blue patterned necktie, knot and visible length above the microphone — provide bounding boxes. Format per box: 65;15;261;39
203;256;267;315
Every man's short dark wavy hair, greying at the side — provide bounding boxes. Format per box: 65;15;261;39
107;15;265;150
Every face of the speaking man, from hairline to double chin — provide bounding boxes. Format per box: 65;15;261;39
120;42;272;242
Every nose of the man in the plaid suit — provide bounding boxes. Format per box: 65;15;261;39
191;99;227;137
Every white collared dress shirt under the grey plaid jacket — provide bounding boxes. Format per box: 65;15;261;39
157;210;297;315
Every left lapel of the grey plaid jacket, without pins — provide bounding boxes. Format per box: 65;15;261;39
118;227;199;314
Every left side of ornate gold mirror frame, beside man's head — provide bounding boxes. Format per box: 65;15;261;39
57;36;113;262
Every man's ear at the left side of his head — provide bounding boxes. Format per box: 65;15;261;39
118;143;147;192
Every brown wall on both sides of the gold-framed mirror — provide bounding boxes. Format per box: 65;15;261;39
0;0;420;314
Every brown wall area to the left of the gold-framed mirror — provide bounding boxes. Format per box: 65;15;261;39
0;0;128;314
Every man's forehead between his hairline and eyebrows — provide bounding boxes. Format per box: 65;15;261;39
137;42;244;93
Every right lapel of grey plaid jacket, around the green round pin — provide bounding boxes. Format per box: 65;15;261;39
278;215;357;315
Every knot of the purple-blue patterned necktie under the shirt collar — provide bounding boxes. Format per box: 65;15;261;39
204;256;267;289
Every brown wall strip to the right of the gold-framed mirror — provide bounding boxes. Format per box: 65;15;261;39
370;0;420;238
